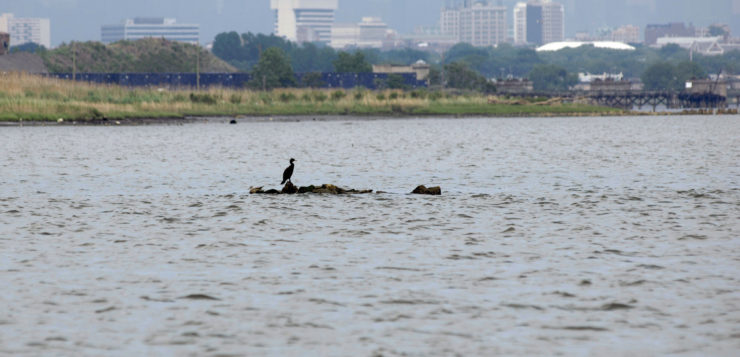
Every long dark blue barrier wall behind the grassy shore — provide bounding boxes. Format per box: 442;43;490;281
46;72;427;89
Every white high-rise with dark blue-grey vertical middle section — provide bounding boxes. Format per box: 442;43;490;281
514;0;565;45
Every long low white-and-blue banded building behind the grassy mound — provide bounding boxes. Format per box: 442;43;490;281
100;17;200;44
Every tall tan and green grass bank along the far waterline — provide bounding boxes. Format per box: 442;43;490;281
0;73;623;121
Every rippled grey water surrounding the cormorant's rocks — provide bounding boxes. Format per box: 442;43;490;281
0;117;740;356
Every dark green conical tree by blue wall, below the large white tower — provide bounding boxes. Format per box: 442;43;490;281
250;47;295;89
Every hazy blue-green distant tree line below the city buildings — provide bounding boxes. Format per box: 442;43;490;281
213;32;740;91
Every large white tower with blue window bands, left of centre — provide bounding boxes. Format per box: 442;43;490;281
270;0;339;44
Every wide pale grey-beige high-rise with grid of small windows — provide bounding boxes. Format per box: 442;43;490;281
440;0;508;47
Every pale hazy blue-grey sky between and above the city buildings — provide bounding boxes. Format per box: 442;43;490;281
0;0;740;45
